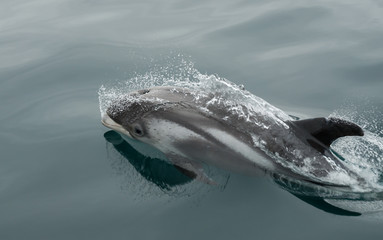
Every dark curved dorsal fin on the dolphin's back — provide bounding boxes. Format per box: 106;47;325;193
293;118;364;147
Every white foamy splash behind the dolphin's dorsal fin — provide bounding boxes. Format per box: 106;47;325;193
330;103;383;191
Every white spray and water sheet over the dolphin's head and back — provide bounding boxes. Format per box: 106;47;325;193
98;55;291;128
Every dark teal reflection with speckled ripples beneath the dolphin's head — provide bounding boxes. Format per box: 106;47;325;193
104;131;230;197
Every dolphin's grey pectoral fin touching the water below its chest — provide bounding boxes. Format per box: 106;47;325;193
166;154;217;185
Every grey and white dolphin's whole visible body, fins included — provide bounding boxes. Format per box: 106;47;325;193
102;87;364;186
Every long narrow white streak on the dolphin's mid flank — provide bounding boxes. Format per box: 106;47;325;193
206;128;274;170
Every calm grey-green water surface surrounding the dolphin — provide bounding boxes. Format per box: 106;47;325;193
0;0;383;239
